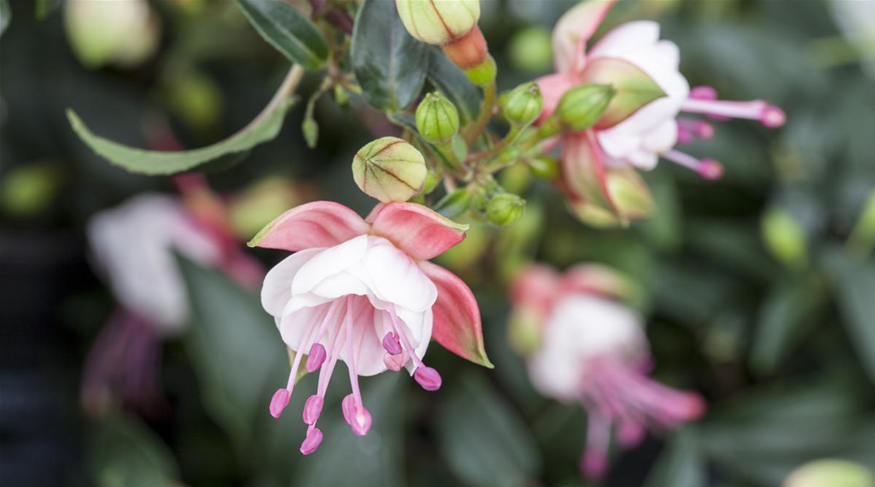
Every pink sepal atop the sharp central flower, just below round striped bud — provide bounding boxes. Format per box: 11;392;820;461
368;203;468;260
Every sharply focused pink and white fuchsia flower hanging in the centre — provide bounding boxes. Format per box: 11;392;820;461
250;201;492;455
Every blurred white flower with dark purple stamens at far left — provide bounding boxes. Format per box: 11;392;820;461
82;191;263;414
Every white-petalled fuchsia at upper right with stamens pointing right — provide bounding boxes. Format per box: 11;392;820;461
537;0;786;221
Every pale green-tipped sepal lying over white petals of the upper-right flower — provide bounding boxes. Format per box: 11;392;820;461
583;58;667;130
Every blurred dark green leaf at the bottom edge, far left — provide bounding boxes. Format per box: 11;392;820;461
88;416;179;487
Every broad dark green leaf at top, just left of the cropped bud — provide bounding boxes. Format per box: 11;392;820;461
351;0;429;112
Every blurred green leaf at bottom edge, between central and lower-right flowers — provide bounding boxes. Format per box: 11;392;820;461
437;374;541;487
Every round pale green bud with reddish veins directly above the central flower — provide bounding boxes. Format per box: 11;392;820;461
352;137;428;203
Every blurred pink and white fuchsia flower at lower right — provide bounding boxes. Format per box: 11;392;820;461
511;265;705;478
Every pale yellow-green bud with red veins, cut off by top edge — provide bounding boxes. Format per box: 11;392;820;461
395;0;480;45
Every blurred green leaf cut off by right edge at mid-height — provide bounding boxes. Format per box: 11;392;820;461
826;249;875;383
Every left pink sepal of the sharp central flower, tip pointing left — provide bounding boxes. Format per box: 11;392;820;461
248;201;370;252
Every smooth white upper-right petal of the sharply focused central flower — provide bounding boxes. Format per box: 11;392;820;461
362;237;437;311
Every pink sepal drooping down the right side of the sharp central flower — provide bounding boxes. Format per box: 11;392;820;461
419;262;493;369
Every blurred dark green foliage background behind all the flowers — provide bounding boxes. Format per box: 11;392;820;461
0;0;875;487
